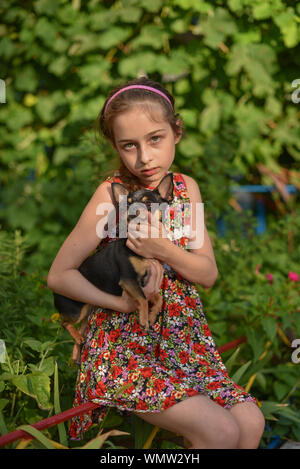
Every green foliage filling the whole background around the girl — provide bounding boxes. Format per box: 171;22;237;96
0;0;300;448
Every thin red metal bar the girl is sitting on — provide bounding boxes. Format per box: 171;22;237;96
0;336;247;448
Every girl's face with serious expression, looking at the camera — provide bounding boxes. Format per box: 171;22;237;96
113;105;181;187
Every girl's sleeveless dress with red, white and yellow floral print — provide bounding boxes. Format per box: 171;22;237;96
69;173;257;440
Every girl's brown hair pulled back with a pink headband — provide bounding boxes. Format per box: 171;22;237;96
94;77;182;191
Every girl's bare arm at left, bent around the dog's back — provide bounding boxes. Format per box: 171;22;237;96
47;182;136;312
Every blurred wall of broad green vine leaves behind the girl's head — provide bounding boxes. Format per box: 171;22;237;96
0;0;300;275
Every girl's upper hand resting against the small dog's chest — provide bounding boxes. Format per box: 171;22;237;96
126;212;170;259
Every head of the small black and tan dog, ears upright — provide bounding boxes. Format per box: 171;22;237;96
111;173;174;222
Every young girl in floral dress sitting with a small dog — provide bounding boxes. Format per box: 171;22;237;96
48;78;264;448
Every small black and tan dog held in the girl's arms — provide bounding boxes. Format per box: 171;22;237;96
54;173;174;362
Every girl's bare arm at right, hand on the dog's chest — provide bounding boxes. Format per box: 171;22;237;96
126;175;218;288
